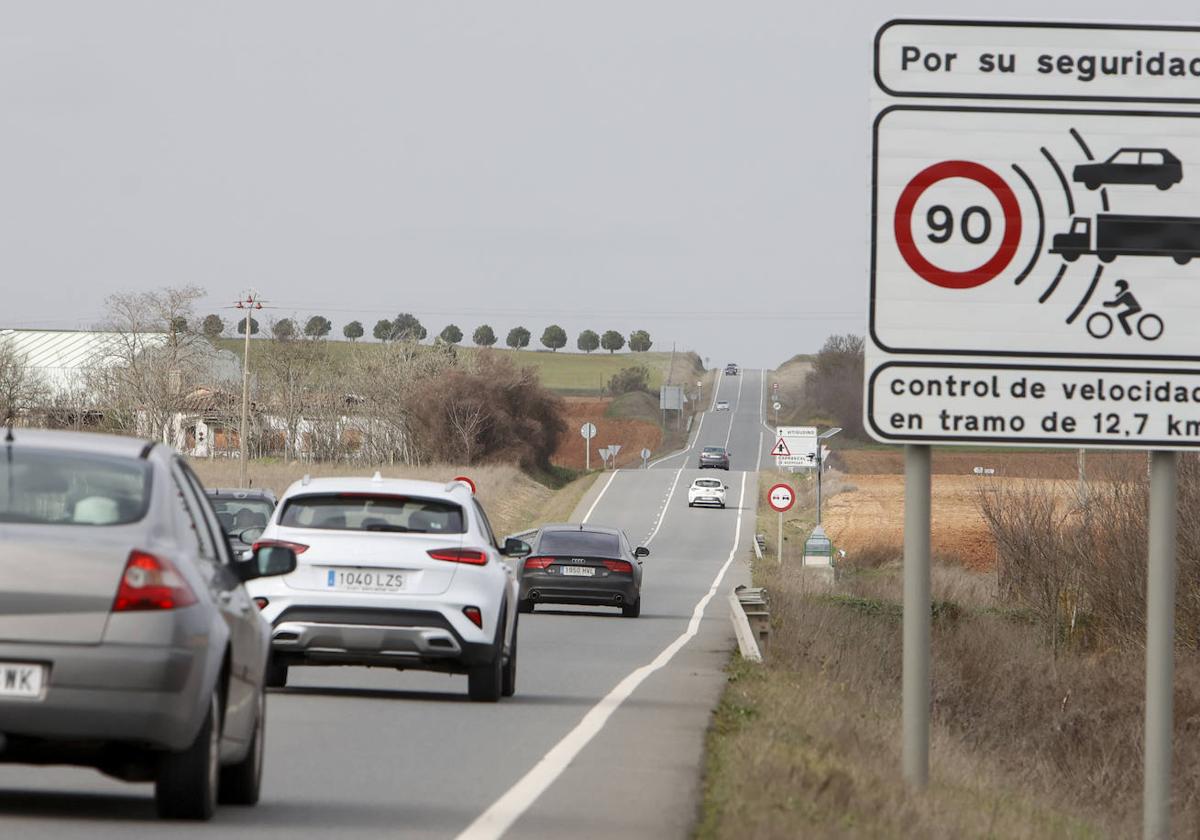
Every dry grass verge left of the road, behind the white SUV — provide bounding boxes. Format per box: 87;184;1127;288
192;460;598;538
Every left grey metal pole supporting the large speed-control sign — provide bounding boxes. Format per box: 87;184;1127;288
901;444;931;790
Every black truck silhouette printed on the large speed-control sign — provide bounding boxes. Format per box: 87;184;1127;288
1050;212;1200;265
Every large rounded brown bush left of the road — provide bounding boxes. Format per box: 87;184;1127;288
410;353;566;470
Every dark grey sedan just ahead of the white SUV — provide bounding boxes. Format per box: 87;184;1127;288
521;524;650;618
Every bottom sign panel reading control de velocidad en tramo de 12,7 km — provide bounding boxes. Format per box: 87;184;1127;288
868;364;1200;445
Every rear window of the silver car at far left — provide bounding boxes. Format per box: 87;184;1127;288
0;445;151;526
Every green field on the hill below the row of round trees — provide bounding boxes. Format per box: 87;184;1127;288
217;338;700;396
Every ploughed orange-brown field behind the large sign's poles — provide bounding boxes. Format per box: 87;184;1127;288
824;449;1146;571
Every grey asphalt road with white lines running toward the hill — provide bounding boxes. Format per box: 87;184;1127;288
0;371;773;840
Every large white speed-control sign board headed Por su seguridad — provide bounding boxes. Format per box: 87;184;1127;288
865;22;1200;449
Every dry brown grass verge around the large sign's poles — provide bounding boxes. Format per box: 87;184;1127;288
697;562;1200;839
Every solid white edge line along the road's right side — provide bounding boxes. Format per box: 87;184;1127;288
457;473;746;840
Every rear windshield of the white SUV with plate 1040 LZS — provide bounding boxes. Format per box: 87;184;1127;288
280;493;467;534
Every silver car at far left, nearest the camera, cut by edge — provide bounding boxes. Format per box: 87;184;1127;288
0;428;295;820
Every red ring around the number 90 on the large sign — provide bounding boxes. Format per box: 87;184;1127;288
894;161;1021;289
